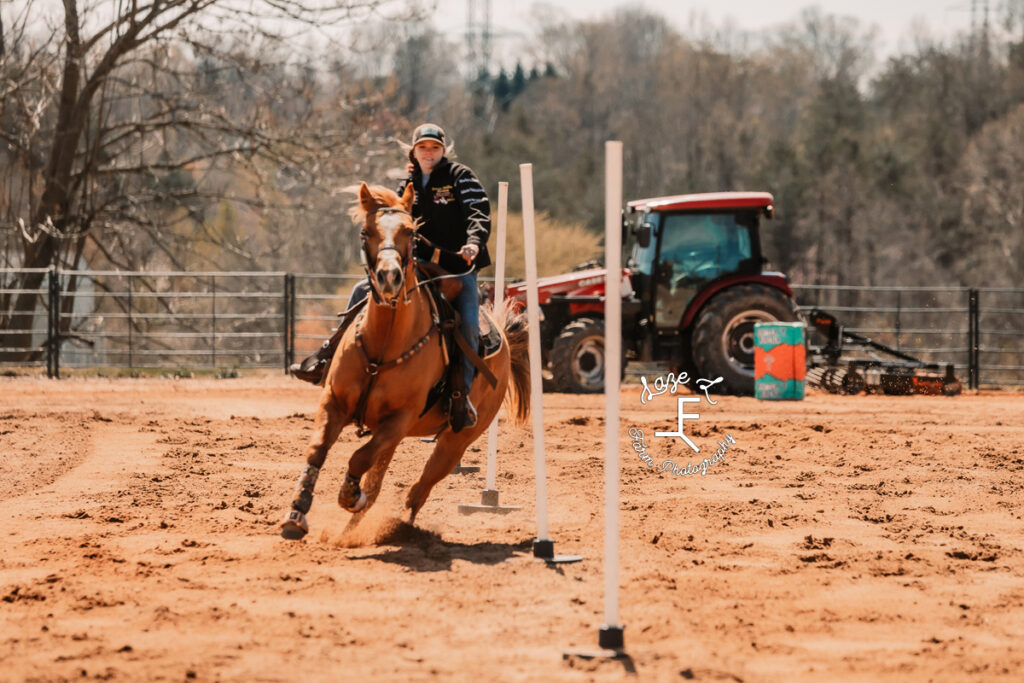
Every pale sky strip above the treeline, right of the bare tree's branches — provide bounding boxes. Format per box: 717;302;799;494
434;0;974;67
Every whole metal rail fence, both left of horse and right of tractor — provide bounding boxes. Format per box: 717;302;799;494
0;268;1024;388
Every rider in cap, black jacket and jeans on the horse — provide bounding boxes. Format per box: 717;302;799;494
291;123;490;426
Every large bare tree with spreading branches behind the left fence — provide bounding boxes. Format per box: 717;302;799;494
0;0;411;360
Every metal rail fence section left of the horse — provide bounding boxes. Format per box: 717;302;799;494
0;268;359;377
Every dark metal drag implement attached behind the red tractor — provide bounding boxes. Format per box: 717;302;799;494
807;309;963;396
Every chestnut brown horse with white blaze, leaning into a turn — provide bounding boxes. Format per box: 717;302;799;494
281;183;529;539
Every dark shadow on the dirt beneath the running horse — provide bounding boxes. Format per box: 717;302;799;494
352;521;532;571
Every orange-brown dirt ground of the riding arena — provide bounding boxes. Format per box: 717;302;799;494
0;376;1024;681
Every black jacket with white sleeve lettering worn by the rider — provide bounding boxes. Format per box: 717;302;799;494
398;157;490;272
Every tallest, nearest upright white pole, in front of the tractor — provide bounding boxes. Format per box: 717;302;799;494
604;141;623;627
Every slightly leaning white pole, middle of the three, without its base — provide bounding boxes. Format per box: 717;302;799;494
519;164;550;541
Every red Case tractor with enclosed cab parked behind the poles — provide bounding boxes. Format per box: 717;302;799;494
507;193;797;394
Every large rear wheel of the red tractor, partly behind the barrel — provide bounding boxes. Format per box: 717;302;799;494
692;285;797;395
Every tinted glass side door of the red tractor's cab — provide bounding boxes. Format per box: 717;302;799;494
654;213;753;329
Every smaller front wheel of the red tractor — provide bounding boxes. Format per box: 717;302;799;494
551;317;605;393
